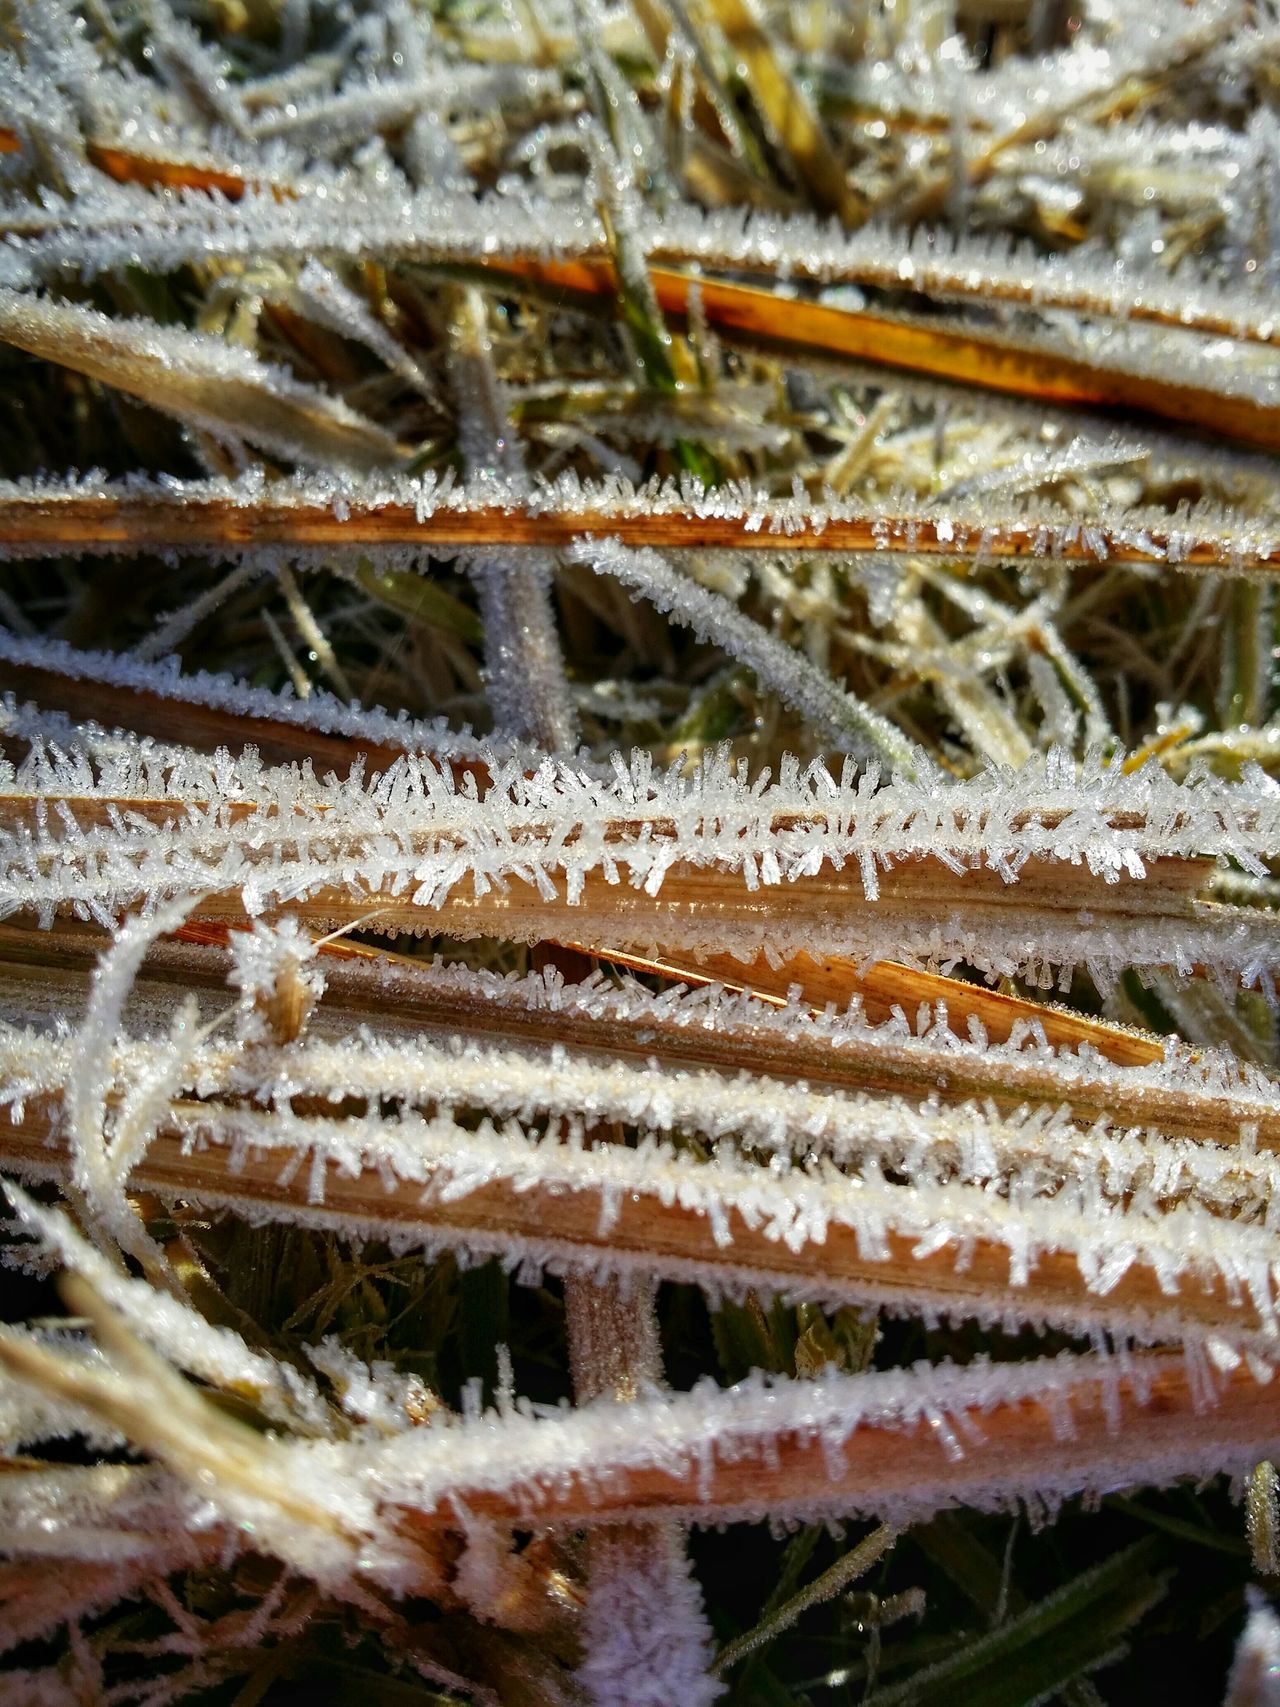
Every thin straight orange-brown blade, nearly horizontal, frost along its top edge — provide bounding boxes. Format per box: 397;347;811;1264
0;473;1280;574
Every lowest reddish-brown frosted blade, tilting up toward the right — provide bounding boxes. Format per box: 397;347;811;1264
5;1304;1277;1570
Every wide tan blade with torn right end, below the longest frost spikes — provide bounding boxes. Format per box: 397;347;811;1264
0;770;1280;983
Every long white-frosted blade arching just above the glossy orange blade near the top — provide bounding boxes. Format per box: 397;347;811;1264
10;168;1278;345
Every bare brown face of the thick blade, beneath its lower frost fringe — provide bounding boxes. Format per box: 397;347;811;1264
0;1101;1270;1350
